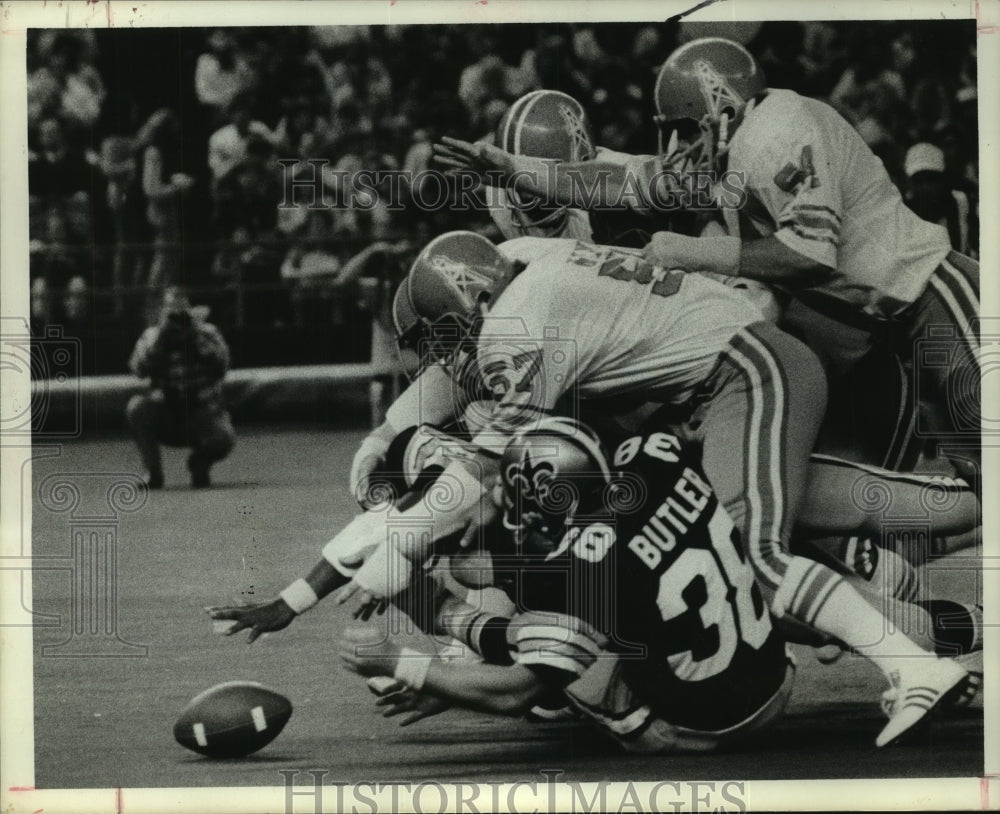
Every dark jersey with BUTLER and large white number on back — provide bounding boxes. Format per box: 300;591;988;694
494;432;787;734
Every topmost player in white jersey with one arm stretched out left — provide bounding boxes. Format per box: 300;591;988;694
435;38;980;484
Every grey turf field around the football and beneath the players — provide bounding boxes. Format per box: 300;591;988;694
32;430;983;789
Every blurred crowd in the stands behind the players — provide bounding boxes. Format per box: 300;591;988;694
28;21;978;364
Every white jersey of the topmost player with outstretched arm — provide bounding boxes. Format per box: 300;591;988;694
723;90;950;324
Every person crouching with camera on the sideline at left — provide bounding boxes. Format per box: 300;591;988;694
125;288;235;489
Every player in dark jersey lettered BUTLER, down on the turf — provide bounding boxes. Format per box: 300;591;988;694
340;418;794;752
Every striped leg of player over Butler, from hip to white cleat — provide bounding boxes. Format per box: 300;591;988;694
695;324;967;745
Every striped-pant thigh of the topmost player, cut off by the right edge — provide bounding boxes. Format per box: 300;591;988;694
907;252;982;491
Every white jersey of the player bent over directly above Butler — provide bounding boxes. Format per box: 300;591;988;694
476;238;764;447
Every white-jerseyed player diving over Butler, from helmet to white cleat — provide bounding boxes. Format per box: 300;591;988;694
209;233;967;743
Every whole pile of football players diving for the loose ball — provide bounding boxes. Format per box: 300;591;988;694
210;38;982;752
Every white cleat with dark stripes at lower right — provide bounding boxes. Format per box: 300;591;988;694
875;659;970;746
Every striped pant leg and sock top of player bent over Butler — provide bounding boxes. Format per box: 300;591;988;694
689;323;843;625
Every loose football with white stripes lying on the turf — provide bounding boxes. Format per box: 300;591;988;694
174;681;292;757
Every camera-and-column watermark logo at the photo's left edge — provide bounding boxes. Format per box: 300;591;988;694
0;317;148;658
